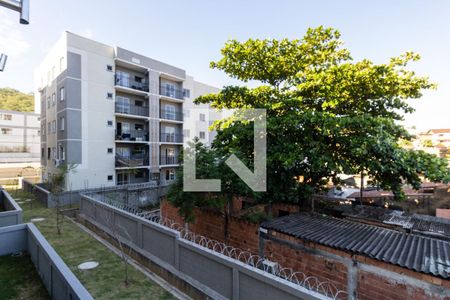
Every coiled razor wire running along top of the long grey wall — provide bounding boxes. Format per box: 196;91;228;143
95;195;347;299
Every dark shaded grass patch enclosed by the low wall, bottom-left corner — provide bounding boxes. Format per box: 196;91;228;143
0;255;50;300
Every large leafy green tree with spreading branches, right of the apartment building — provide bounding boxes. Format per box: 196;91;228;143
196;27;449;202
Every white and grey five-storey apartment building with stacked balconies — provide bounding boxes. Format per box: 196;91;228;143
35;32;220;189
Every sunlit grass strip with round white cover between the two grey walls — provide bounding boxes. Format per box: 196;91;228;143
10;191;175;299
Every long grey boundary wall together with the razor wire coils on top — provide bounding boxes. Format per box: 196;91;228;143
80;194;347;300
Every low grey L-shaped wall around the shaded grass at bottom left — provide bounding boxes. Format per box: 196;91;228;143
0;223;93;300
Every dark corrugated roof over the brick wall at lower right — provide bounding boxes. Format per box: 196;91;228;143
261;214;450;278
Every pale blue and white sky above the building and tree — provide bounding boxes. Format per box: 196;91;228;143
0;0;450;130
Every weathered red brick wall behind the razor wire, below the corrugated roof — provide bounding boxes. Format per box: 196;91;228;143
161;201;450;300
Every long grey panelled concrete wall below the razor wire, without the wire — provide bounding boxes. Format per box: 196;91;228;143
80;195;329;300
